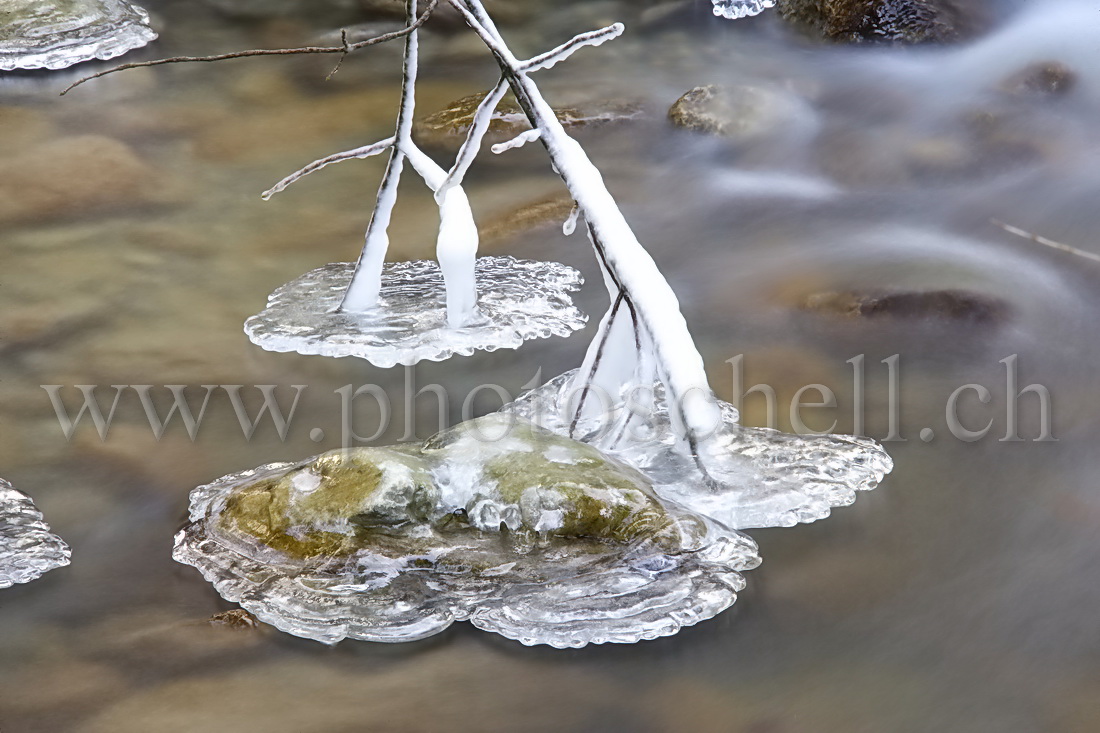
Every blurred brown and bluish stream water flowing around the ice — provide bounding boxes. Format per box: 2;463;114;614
0;0;1100;733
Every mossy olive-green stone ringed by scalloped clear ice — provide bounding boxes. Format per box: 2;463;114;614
174;414;759;647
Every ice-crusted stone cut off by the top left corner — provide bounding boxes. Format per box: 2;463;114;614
0;0;156;72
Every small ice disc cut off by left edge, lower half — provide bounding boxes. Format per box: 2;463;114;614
0;479;69;588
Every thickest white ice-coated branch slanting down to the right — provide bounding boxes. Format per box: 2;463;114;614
450;0;721;464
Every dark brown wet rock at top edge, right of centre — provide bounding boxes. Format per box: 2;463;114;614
779;0;974;43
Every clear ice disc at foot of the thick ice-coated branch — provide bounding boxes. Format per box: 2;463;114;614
503;371;893;529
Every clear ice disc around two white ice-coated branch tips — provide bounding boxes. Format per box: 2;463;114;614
244;256;587;368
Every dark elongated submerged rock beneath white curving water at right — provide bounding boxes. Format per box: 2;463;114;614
801;291;1009;325
